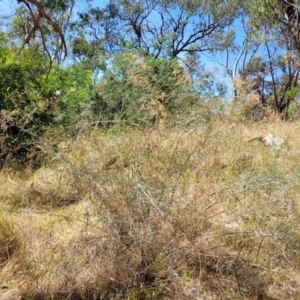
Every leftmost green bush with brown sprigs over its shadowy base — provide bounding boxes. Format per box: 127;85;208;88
0;45;49;165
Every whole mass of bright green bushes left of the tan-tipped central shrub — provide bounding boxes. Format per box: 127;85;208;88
0;41;91;166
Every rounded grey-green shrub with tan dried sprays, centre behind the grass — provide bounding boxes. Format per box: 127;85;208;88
92;52;199;125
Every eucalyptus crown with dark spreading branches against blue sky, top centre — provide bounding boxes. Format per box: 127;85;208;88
79;0;237;59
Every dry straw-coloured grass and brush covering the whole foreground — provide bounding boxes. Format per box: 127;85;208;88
0;115;300;300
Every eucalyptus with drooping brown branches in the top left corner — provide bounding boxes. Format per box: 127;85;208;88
1;0;75;66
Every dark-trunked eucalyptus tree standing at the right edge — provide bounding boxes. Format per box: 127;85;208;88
244;0;300;117
